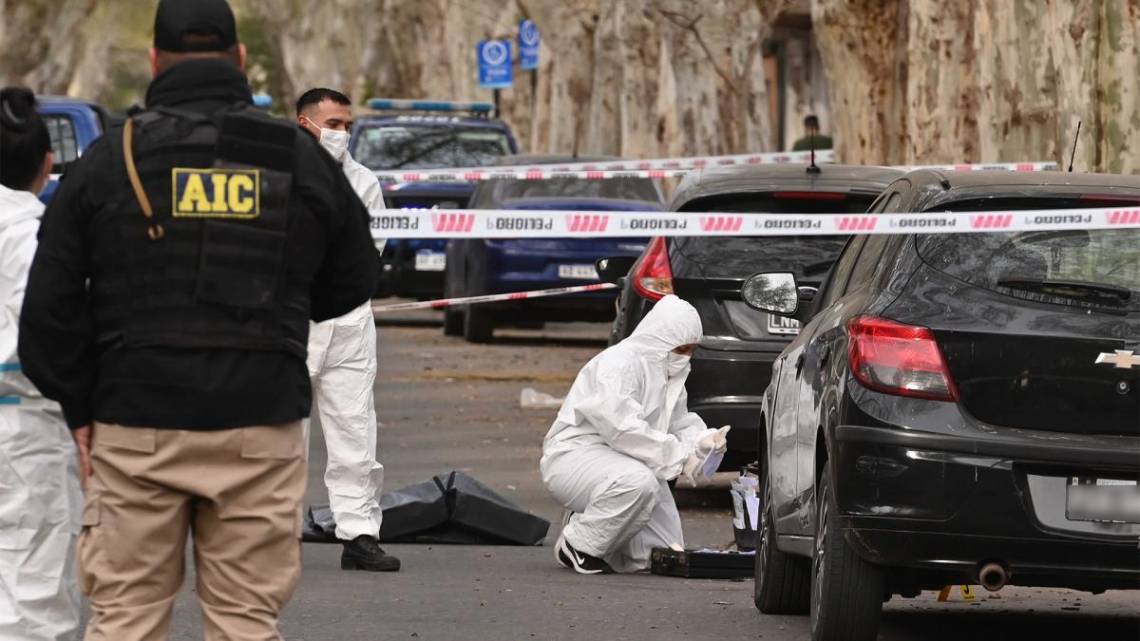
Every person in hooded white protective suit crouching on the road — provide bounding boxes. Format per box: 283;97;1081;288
539;295;730;574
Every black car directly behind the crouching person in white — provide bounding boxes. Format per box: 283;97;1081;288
602;165;902;469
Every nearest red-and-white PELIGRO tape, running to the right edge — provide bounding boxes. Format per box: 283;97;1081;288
372;208;1140;238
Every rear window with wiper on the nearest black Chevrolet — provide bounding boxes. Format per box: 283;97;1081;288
917;197;1140;310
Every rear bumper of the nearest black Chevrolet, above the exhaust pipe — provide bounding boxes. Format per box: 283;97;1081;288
831;424;1140;591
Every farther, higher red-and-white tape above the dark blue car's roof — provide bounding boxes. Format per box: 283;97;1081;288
375;149;834;182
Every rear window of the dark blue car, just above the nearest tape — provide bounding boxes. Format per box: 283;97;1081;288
473;178;661;209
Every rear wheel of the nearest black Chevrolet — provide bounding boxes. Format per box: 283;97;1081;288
812;469;886;641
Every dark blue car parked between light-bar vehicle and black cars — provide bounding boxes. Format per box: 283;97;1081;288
443;154;663;342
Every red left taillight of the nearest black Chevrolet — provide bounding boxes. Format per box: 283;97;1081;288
847;316;958;400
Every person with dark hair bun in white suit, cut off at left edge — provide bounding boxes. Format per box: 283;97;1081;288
0;88;83;641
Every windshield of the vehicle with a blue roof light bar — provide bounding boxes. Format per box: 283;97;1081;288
352;127;511;170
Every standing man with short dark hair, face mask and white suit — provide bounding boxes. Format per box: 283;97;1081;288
296;89;400;571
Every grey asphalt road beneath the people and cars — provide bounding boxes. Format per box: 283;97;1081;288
156;314;1140;641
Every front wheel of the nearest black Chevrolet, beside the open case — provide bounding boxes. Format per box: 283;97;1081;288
752;481;812;615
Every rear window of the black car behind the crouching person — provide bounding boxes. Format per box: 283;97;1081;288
669;192;876;281
